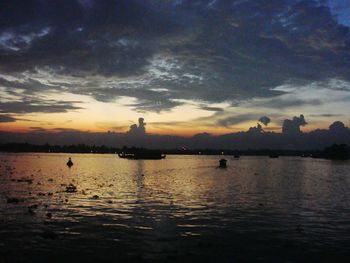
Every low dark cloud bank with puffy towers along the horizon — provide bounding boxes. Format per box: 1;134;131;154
0;116;350;150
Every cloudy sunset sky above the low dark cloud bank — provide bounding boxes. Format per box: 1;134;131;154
0;0;350;135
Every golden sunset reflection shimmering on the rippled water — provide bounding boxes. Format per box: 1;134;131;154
0;154;343;224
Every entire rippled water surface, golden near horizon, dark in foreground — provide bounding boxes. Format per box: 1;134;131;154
0;154;350;262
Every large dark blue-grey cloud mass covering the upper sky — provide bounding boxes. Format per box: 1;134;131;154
0;0;350;111
